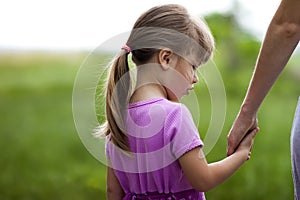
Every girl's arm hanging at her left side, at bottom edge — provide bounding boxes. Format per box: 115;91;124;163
106;167;125;200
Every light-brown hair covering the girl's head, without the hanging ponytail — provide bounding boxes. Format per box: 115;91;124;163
127;4;214;65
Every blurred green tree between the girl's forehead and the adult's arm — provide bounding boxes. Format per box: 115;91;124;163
205;13;260;68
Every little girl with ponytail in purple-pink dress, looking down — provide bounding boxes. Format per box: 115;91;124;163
102;4;258;200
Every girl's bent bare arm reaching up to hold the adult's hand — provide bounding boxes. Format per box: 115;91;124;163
179;129;258;192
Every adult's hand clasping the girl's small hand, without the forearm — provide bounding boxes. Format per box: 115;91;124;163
227;109;258;156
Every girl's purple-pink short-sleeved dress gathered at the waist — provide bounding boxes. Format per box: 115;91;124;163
106;98;205;200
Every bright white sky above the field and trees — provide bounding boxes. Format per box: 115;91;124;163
0;0;280;50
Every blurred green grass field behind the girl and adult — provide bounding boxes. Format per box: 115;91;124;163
0;52;300;200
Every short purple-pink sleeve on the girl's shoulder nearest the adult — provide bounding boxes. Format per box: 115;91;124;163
165;104;203;159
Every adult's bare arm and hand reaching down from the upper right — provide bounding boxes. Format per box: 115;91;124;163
227;0;300;155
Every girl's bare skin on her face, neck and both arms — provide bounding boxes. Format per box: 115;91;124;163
107;49;258;200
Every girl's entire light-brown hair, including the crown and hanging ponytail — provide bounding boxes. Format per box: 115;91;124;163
101;4;214;151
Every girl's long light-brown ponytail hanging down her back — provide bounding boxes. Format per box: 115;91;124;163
104;50;132;151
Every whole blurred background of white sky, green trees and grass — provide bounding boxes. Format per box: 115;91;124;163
0;0;300;200
